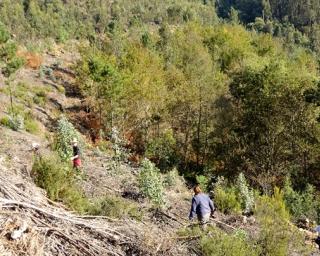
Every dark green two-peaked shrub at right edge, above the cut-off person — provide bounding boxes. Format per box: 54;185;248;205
283;178;319;221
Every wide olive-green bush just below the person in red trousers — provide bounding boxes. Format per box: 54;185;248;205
32;156;89;213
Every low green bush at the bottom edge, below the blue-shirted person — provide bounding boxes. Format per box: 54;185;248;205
200;229;260;256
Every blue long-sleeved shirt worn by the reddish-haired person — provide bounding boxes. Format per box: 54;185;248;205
189;193;214;219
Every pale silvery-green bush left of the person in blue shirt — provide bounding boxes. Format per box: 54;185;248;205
138;159;165;207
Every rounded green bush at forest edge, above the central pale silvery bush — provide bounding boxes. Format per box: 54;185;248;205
145;130;176;170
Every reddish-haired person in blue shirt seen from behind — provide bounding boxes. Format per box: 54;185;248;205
189;185;215;229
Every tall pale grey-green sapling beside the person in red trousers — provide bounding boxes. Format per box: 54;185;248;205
55;116;84;161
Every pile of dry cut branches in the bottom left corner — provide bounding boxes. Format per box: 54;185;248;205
0;174;140;256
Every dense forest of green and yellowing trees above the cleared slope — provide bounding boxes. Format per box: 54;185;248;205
0;0;320;198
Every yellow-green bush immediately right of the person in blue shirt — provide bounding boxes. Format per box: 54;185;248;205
214;180;241;214
